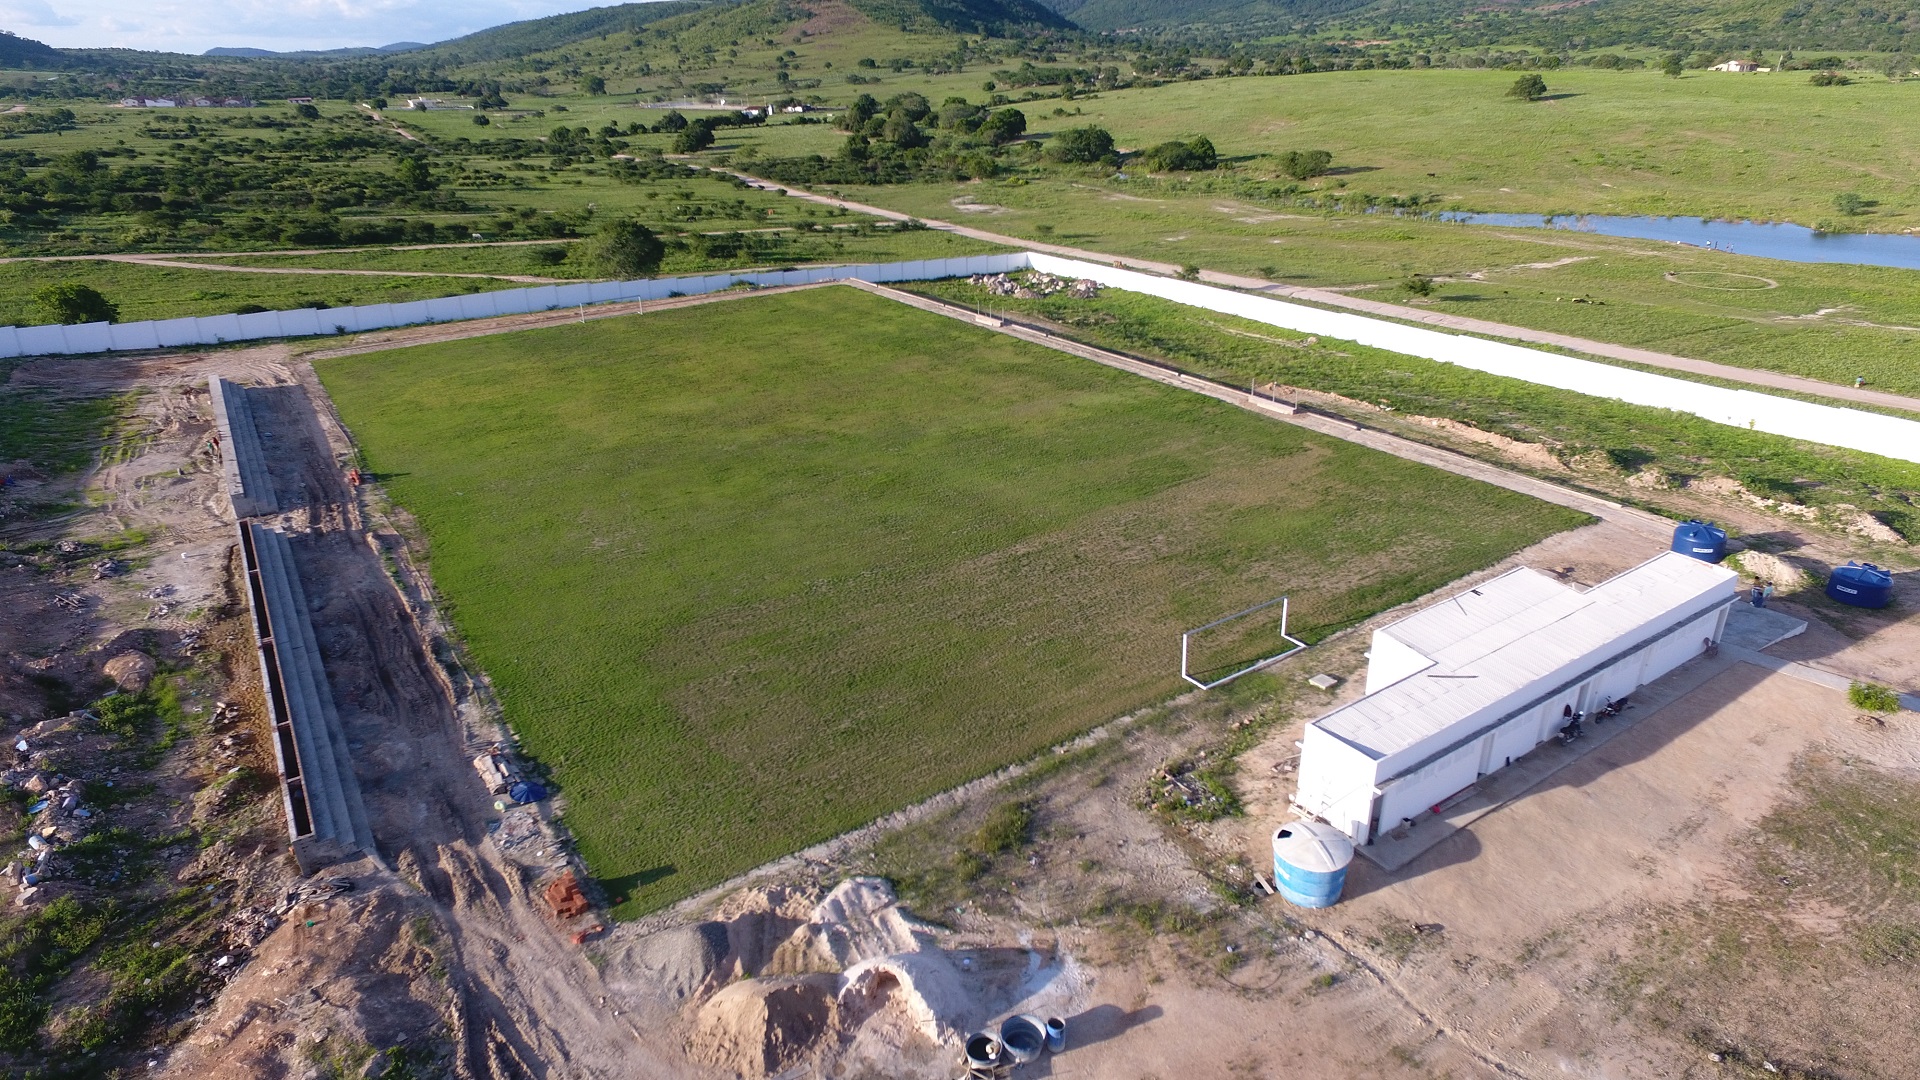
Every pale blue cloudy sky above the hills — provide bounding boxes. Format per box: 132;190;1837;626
0;0;645;52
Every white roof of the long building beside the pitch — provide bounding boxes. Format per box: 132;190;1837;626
1313;552;1740;759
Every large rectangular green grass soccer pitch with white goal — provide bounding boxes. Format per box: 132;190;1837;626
319;288;1580;915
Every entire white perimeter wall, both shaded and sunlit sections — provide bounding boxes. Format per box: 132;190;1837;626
15;252;1920;463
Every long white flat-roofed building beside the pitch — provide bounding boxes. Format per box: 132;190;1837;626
1294;552;1740;844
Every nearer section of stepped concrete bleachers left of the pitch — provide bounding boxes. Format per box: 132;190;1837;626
240;521;376;871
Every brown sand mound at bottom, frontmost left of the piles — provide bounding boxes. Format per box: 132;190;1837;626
689;974;839;1076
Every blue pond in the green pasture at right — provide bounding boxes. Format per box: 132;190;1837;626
1444;213;1920;269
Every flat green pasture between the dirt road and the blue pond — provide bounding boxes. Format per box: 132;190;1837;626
775;179;1920;394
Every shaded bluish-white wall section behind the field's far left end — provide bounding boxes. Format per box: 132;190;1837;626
0;252;1027;357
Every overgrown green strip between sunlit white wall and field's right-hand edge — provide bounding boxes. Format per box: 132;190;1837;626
916;272;1920;538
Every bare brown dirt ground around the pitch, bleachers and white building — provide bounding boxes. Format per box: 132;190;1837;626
0;288;1920;1080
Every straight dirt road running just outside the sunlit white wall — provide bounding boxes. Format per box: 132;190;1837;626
732;173;1920;413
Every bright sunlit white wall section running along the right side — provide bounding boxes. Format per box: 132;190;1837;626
1029;252;1920;463
